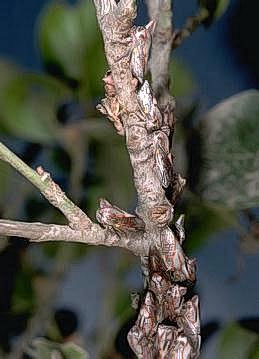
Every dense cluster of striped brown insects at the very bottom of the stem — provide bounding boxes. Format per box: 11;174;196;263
128;248;200;359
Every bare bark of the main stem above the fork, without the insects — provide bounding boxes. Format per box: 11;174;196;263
94;0;172;240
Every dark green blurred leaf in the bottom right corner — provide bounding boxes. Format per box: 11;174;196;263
219;323;258;359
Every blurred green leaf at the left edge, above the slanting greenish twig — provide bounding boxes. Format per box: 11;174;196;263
0;72;70;144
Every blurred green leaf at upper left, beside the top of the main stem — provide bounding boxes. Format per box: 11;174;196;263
38;0;105;96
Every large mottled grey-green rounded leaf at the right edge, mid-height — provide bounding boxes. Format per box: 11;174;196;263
200;90;259;209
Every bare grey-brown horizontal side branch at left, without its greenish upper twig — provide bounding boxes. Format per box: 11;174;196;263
0;219;148;256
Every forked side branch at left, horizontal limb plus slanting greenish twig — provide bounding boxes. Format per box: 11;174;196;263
0;143;149;256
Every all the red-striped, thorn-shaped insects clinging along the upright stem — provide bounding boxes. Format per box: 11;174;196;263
96;6;200;359
